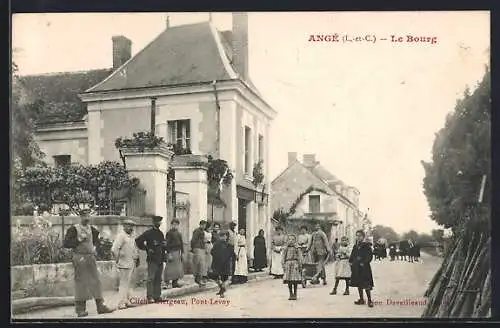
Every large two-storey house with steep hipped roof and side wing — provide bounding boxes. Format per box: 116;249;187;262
22;13;276;253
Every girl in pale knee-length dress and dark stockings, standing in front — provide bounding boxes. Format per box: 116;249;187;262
282;235;302;300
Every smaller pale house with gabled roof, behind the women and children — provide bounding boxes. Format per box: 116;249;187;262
271;152;364;241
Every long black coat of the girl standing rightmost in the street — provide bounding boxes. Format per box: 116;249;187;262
349;242;374;290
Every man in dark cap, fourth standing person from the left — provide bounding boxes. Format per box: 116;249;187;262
163;218;184;288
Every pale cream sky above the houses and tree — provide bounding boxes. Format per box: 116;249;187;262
12;11;490;233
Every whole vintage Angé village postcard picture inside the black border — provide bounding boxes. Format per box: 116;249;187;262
10;11;492;322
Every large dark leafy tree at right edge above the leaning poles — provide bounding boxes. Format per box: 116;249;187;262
422;69;491;230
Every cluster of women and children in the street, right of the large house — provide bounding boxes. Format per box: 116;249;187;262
270;223;374;307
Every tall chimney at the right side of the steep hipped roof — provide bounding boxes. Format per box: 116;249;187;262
231;13;248;80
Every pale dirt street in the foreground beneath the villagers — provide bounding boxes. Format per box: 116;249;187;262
16;253;441;319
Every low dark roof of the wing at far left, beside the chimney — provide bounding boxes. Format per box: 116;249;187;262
19;68;112;123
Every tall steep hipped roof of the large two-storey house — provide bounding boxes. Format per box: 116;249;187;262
87;22;250;92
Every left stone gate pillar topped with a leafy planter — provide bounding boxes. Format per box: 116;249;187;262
122;145;173;233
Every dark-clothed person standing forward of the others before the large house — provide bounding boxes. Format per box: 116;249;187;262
211;231;234;298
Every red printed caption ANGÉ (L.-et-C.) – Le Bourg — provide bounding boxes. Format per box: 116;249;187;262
308;33;438;44
